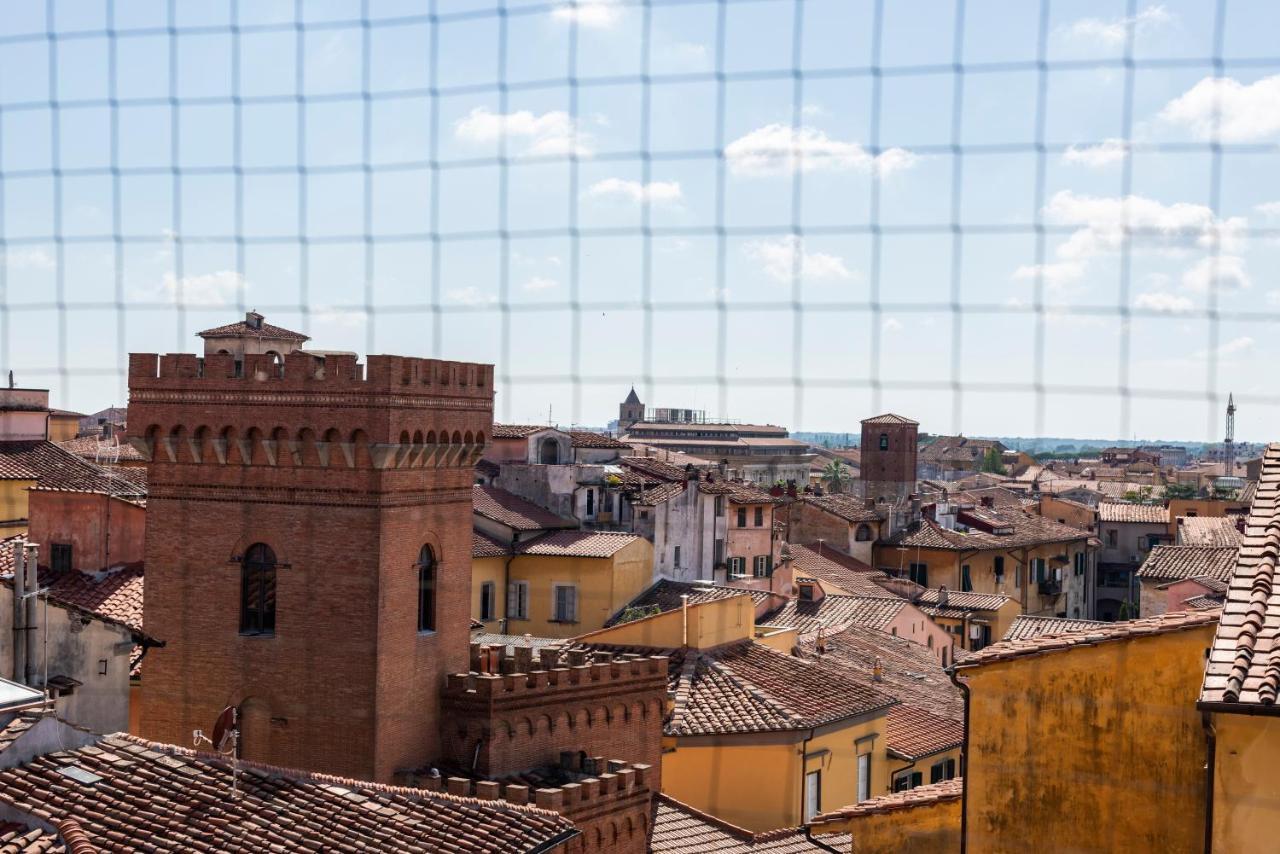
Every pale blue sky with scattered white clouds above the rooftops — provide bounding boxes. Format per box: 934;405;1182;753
0;0;1280;440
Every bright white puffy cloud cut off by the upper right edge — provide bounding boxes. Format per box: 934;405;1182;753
1160;74;1280;142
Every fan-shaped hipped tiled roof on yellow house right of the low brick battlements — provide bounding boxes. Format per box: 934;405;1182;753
666;640;895;736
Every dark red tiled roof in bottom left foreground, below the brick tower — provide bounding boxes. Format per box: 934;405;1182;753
0;734;573;853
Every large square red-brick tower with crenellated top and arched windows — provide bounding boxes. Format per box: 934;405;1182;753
129;338;493;781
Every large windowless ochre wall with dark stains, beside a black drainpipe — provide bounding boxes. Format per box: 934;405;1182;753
960;625;1225;853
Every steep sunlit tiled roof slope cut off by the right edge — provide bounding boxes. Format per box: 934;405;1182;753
1194;444;1280;707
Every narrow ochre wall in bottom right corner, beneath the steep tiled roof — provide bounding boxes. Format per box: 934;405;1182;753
1213;714;1280;851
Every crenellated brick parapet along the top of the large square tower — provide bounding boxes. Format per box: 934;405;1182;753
129;350;493;399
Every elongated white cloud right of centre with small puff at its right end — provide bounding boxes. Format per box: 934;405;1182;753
724;124;918;175
